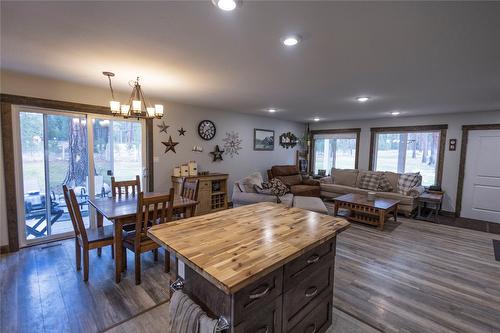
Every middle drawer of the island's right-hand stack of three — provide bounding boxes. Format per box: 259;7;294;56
283;262;333;323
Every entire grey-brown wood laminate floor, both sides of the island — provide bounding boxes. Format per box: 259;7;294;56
0;218;500;333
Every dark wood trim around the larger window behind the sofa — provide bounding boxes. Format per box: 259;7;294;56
369;124;448;186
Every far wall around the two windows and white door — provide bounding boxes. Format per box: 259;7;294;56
312;111;500;211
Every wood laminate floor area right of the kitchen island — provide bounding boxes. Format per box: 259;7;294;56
334;218;500;333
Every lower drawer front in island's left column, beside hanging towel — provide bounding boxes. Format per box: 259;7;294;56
233;296;283;333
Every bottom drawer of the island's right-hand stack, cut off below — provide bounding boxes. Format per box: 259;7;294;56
285;292;333;333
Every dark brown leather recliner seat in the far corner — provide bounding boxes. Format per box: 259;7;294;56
267;165;321;197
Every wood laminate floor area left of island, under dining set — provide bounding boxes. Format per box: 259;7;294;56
0;240;169;333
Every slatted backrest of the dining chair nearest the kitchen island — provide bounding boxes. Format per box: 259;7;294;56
135;188;174;245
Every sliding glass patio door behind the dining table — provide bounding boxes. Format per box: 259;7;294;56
16;108;145;244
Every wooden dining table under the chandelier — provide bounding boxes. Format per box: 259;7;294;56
89;192;198;283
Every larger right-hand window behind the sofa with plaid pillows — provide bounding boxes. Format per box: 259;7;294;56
371;126;446;186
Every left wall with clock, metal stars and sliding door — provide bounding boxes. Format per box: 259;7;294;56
0;72;304;245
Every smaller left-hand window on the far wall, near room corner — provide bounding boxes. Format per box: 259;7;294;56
312;129;360;174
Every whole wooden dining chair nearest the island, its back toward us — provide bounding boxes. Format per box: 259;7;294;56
123;188;174;284
